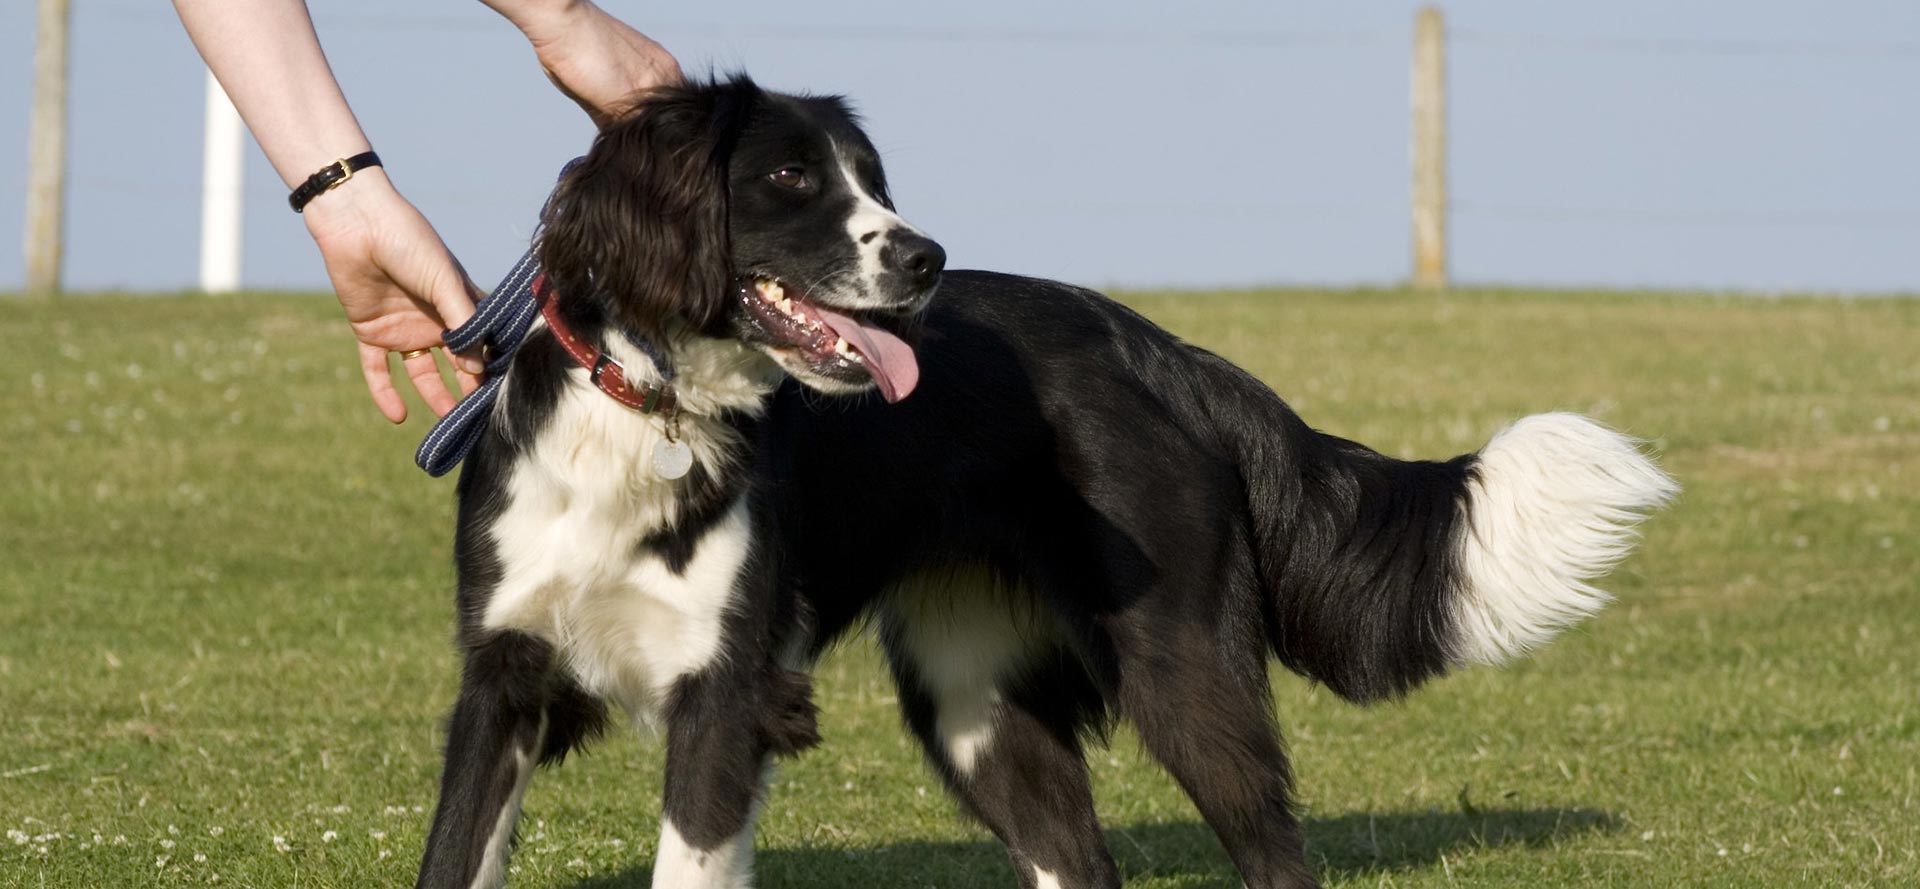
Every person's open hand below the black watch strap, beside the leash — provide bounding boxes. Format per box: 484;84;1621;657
303;167;482;422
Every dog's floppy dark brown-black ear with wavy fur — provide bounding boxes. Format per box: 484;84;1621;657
540;84;755;340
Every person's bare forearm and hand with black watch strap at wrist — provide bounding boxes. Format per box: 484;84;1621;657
173;0;480;422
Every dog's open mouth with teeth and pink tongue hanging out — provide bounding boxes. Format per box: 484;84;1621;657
737;276;920;401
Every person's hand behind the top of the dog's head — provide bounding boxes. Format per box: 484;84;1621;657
503;0;684;127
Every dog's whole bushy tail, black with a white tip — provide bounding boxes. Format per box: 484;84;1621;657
1213;355;1678;701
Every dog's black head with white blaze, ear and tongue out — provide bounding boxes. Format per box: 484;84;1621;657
540;77;947;401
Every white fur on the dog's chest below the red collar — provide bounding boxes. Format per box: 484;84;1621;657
482;330;768;722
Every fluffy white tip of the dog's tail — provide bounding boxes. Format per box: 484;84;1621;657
1453;413;1680;664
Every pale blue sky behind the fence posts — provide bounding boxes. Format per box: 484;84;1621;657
0;0;1920;292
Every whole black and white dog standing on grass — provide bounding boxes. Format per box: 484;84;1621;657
420;79;1674;889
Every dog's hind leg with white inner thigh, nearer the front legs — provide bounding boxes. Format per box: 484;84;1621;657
881;589;1119;889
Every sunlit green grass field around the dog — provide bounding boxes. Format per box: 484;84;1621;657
0;292;1920;889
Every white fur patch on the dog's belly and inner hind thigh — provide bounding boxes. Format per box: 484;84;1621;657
883;568;1050;778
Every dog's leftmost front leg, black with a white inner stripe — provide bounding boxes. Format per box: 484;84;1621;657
417;632;603;889
